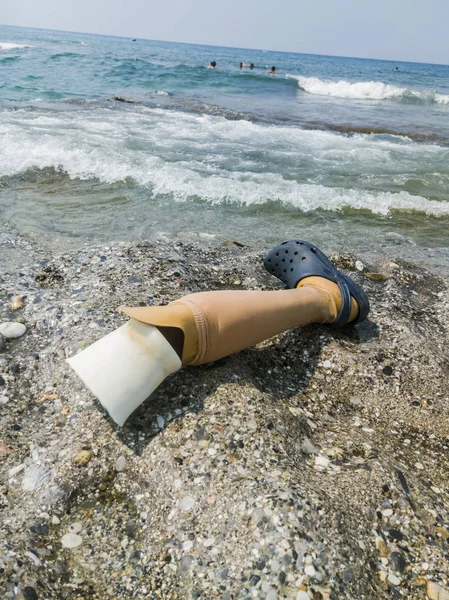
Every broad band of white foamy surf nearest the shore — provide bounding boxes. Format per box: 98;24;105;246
0;107;449;216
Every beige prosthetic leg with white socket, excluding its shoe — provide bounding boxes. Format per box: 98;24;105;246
68;239;369;425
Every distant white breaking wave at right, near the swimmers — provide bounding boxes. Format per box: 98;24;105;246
287;75;449;105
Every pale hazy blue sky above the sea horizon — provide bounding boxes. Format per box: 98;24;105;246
0;0;449;64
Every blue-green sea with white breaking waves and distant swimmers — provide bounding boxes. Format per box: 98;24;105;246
0;26;449;275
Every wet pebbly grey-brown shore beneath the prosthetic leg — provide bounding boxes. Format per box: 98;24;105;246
0;240;449;600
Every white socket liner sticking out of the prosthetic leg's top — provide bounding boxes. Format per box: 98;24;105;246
67;319;182;426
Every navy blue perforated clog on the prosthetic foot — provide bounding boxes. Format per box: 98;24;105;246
264;240;369;328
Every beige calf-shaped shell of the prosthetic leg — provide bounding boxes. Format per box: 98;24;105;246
122;287;337;365
